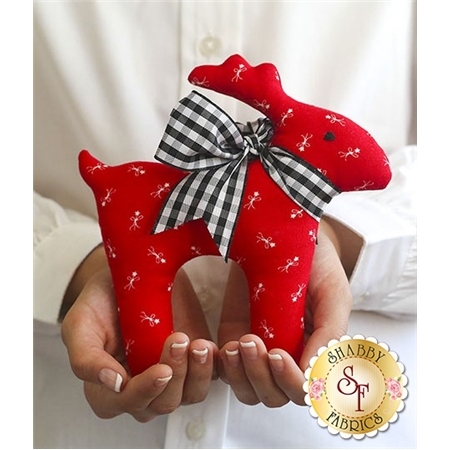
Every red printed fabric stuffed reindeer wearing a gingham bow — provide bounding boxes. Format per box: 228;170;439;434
79;55;391;374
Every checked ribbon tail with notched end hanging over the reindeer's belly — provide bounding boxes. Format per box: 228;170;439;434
152;159;247;260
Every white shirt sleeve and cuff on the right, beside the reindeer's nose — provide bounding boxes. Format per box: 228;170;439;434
326;146;417;318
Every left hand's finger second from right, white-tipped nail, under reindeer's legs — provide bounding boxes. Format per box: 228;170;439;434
148;332;189;415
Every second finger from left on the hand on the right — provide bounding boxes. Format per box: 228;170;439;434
239;334;289;407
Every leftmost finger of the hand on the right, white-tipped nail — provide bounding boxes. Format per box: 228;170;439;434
219;341;260;405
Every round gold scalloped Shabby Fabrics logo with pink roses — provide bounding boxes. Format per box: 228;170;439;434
303;335;408;439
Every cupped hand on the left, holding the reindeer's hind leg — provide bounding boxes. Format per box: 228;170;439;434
62;250;218;422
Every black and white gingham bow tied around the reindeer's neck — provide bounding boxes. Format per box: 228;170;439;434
152;91;339;259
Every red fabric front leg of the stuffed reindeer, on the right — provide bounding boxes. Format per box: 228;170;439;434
227;227;314;362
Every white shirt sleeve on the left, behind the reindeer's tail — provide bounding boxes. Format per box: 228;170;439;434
33;192;101;324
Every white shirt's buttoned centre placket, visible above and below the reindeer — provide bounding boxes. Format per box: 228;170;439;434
165;1;242;448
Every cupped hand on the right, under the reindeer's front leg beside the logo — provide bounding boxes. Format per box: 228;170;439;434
219;220;352;407
